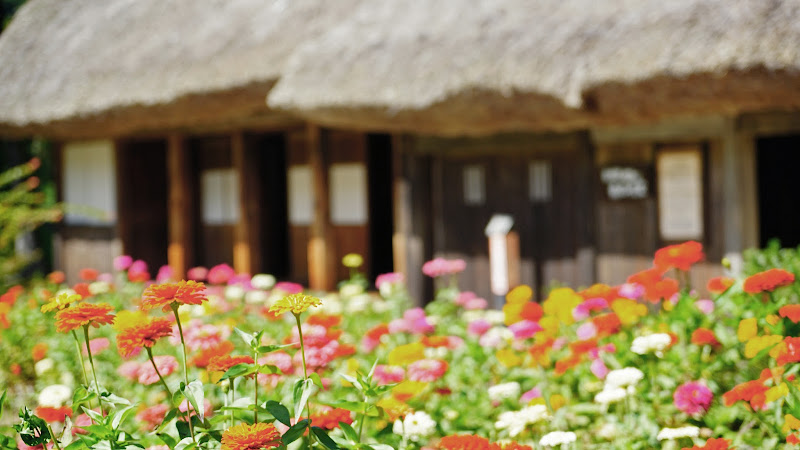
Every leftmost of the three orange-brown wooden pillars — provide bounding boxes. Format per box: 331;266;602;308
167;135;195;278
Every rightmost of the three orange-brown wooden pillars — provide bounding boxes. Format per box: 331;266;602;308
306;125;336;291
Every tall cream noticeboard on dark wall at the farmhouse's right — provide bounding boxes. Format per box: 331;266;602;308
656;147;703;240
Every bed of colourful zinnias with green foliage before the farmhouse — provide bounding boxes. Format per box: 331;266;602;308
0;242;800;450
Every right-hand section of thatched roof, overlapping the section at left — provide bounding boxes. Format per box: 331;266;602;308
269;0;800;134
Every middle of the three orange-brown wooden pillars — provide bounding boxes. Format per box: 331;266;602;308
231;131;260;275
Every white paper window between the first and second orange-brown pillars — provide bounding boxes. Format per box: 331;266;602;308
200;168;239;225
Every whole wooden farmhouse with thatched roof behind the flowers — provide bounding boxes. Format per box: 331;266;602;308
0;0;800;299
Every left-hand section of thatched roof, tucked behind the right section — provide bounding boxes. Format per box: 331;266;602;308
0;0;355;139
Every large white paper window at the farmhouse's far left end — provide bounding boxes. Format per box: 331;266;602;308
63;140;117;225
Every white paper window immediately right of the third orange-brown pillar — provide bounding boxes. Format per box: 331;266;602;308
330;164;368;225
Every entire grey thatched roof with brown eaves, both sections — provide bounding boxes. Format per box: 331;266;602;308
0;0;800;136
